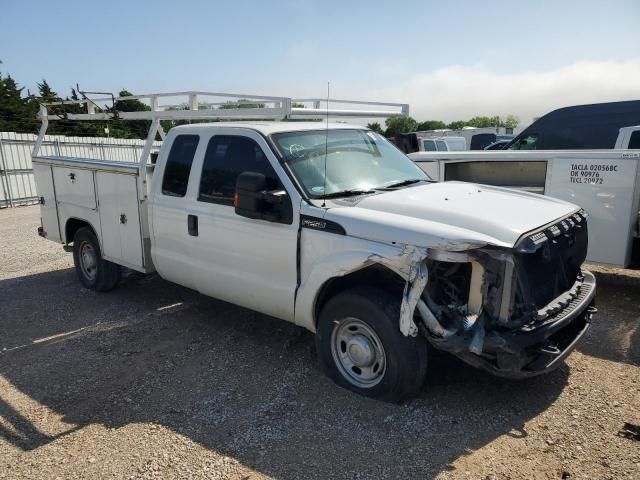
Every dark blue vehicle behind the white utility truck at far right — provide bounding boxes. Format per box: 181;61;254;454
506;100;640;150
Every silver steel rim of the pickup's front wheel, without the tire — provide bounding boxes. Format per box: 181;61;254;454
331;317;387;388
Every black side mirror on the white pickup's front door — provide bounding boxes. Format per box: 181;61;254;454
233;172;292;223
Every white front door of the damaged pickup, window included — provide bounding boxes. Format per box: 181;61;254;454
190;129;299;321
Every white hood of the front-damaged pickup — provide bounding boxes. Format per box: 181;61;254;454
324;182;579;247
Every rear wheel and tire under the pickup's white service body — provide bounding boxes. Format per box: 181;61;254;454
73;227;120;292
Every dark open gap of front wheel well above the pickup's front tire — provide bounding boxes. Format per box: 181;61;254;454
313;264;406;325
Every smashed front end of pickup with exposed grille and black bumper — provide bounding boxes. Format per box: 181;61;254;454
408;211;596;378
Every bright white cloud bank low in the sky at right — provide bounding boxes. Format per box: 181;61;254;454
364;58;640;125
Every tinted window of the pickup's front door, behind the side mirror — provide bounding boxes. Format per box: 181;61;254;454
198;135;280;205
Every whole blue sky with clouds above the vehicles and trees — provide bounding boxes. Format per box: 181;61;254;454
0;0;640;124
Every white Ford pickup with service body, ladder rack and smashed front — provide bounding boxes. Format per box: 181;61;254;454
33;92;596;401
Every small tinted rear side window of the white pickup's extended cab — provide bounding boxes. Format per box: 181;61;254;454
162;135;200;197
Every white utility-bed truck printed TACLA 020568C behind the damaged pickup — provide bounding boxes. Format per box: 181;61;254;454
409;126;640;267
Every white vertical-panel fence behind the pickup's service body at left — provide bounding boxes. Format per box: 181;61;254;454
0;132;161;208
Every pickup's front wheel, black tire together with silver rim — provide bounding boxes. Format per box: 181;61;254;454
316;288;427;402
